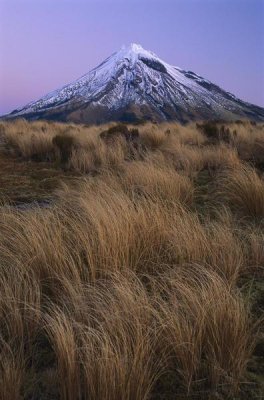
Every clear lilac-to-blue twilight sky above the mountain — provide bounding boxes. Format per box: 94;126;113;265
0;0;264;115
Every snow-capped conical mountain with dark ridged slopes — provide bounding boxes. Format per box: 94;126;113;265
5;43;264;123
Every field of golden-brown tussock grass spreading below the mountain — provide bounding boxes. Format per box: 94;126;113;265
0;121;264;400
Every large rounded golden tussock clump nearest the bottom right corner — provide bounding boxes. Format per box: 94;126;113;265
152;265;254;394
